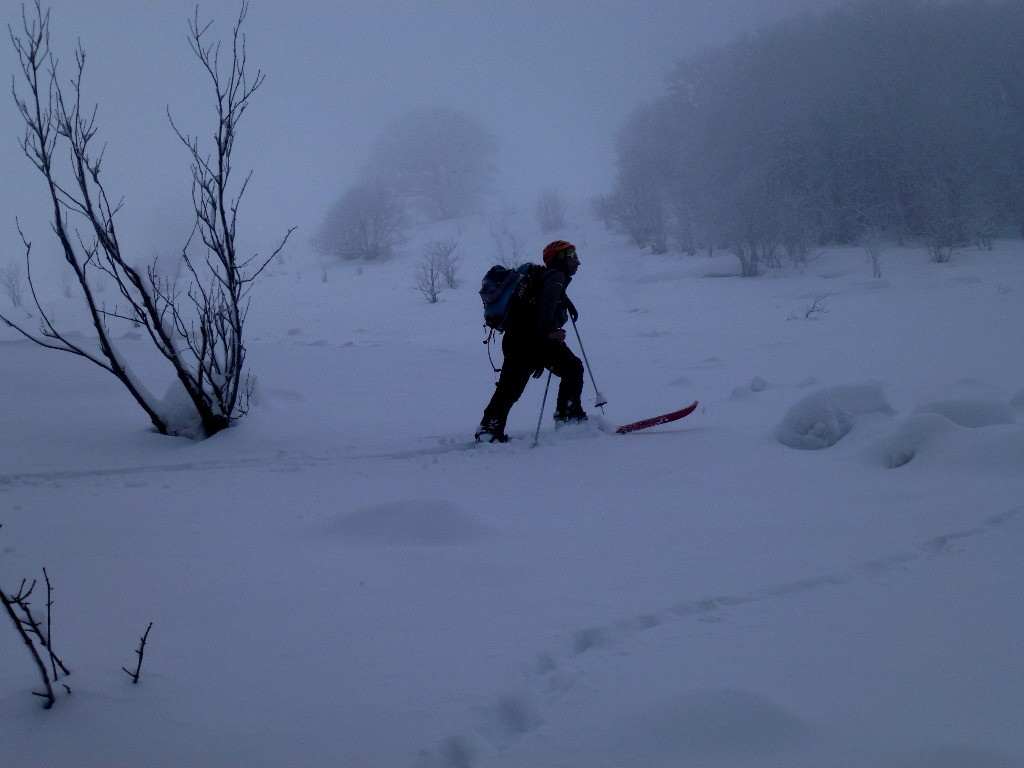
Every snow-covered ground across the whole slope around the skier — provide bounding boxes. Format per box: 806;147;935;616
0;211;1024;768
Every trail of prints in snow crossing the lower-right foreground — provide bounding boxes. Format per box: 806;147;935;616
418;506;1024;768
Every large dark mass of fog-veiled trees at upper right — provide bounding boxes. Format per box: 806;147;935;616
595;0;1024;275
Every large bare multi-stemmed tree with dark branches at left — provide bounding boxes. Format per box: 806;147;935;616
0;0;292;436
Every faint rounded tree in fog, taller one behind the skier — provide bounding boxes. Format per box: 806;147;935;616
366;108;498;221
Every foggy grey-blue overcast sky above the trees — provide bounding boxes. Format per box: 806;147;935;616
0;0;822;263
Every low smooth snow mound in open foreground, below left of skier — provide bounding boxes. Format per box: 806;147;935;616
326;500;489;547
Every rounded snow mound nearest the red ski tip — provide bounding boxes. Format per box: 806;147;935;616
775;384;894;451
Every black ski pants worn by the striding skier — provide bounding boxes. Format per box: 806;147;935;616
480;333;583;432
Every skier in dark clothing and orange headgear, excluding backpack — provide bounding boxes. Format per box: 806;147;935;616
475;240;587;442
